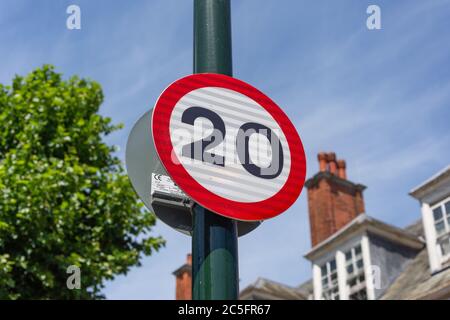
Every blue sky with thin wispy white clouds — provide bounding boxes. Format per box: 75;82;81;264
0;0;450;299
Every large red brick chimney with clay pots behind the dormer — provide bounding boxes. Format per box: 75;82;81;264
305;152;366;246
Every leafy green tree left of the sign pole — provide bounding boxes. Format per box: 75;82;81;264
0;66;164;299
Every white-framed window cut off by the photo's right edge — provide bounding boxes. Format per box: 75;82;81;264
432;199;450;260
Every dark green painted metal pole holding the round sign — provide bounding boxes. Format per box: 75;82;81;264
192;0;239;300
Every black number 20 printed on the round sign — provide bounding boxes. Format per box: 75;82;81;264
181;107;284;179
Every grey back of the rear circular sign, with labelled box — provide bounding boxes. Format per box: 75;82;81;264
125;109;261;236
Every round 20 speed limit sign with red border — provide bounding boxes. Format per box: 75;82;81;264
151;74;306;221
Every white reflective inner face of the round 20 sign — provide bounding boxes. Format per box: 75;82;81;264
170;87;291;202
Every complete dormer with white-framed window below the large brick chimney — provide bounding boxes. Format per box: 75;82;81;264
305;215;426;300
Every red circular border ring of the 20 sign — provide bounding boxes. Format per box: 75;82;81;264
151;73;306;221
